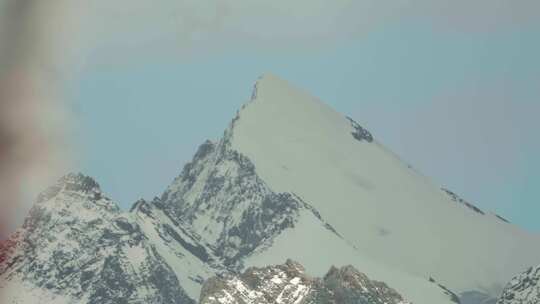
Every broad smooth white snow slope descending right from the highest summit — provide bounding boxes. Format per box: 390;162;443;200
231;75;540;303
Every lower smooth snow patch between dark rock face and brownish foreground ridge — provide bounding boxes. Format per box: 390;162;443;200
245;211;452;304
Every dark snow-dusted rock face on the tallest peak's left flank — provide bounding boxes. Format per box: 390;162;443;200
153;122;306;268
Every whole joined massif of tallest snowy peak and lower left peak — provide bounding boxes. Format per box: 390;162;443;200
0;75;540;304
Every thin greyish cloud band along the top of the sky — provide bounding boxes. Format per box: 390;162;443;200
73;0;540;58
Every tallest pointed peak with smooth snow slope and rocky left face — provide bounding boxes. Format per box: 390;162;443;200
149;75;540;303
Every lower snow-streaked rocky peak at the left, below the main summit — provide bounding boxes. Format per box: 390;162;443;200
0;174;194;304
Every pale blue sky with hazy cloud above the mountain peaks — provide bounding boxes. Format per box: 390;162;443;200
12;0;540;232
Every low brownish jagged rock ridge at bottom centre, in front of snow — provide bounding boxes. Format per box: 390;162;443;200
199;260;408;304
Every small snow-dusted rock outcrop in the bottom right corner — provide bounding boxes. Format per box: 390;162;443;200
497;266;540;304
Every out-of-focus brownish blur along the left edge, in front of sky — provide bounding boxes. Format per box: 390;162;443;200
0;0;73;238
